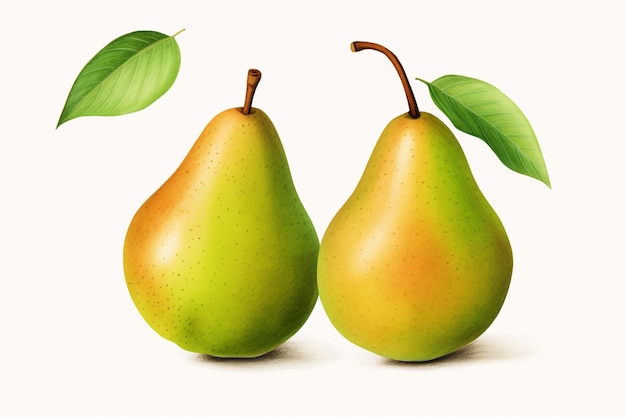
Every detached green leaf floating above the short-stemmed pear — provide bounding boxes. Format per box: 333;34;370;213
57;31;182;128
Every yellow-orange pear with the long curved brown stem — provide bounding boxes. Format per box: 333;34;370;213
318;42;513;362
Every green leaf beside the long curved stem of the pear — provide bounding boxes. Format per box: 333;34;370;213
418;75;550;187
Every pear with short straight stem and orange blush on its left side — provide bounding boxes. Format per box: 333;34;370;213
124;70;319;358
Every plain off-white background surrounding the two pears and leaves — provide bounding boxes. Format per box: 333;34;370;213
0;0;625;416
